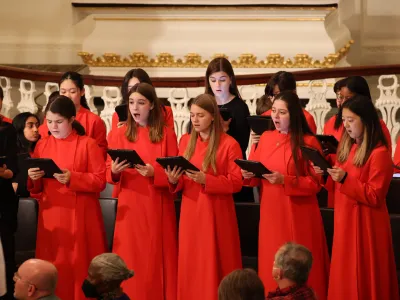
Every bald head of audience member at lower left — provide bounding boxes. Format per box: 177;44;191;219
18;259;58;293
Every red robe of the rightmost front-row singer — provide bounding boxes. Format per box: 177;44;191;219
328;144;399;300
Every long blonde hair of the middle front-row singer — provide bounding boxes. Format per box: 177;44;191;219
184;94;223;173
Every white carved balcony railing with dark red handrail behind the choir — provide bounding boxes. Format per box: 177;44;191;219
0;65;400;155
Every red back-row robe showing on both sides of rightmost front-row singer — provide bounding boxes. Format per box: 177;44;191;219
324;115;392;208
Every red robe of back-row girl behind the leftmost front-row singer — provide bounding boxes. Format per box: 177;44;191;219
39;106;107;159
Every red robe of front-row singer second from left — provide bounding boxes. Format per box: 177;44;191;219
107;125;178;300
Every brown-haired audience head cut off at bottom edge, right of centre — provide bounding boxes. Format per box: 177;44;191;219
218;269;265;300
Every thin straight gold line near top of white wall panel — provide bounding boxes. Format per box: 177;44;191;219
94;16;325;22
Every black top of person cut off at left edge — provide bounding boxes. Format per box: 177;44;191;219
0;122;18;230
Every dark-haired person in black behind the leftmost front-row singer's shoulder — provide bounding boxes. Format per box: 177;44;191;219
12;112;40;197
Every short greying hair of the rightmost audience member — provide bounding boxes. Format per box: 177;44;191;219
275;242;313;285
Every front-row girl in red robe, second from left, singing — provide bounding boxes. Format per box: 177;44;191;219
107;83;178;300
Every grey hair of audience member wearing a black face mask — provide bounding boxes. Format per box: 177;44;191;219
90;253;134;282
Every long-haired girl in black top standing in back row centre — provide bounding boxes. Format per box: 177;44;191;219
204;57;254;202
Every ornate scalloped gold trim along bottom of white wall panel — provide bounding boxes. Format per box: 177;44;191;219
78;40;354;68
